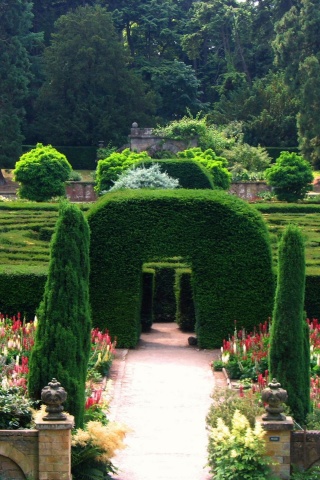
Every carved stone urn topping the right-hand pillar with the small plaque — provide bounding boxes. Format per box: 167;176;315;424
261;378;288;421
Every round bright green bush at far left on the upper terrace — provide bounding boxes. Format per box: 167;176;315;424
13;143;72;202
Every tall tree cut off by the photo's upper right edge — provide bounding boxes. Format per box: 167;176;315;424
274;0;320;165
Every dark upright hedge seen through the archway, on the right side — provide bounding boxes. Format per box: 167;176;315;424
175;268;196;332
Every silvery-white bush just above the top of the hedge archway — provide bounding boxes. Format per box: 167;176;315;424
109;163;179;192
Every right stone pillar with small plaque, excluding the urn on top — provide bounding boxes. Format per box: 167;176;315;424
257;417;293;479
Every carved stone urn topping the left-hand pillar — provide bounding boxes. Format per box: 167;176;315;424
41;378;67;421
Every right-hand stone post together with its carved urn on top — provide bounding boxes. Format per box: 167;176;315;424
257;379;293;480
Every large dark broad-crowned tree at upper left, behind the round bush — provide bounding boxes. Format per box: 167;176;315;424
31;6;153;145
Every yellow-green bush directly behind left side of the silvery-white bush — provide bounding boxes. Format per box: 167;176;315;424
95;148;150;192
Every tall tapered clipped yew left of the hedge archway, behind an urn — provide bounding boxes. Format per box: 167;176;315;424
28;200;91;428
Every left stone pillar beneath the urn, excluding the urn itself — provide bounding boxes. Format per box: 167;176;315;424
36;416;74;480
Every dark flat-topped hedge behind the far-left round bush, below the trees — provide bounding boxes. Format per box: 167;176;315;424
22;145;97;170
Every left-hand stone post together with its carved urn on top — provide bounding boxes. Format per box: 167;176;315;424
36;379;74;480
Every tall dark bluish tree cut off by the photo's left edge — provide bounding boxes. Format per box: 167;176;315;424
0;0;32;183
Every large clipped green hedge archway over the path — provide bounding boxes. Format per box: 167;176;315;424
88;189;274;348
